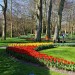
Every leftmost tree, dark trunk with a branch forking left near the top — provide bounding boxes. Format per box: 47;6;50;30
0;0;7;40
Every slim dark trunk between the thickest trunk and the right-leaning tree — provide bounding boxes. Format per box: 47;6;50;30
46;0;52;38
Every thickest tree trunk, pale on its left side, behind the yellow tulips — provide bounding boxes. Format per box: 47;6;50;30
35;0;42;41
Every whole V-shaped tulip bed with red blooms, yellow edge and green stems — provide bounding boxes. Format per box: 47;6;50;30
6;43;75;71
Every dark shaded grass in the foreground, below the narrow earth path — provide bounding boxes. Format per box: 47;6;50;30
0;49;64;75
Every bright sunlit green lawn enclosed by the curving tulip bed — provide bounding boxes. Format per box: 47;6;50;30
40;46;75;62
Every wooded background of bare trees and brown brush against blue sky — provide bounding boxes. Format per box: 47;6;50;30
0;0;75;41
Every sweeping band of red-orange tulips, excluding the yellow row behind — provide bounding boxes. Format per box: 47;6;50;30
6;45;75;71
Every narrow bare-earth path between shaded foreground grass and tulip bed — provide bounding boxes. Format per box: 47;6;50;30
12;57;75;75
